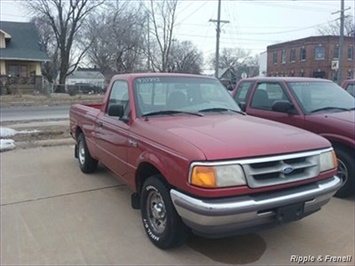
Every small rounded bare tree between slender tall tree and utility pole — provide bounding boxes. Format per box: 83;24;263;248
168;40;203;74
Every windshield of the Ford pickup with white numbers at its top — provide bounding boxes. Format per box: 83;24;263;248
134;76;240;116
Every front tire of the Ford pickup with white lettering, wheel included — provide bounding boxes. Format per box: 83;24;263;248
141;175;189;249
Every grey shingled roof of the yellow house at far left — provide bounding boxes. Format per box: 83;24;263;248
0;21;49;61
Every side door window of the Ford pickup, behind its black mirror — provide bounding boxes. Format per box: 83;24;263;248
106;80;130;116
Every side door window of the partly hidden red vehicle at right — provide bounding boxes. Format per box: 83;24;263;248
251;82;289;110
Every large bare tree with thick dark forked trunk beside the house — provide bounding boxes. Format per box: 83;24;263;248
23;0;104;91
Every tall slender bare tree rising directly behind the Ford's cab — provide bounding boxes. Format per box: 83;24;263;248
148;0;178;72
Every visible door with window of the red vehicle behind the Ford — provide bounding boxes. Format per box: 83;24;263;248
247;81;304;127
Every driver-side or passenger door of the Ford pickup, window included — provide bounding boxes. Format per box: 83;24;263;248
95;80;130;178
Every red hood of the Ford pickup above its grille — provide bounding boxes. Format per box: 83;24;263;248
141;114;330;160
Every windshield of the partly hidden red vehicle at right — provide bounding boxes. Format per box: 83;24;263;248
287;81;355;114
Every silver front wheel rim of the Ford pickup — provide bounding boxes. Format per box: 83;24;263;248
147;191;166;234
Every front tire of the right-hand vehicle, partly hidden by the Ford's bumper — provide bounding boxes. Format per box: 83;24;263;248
335;147;354;198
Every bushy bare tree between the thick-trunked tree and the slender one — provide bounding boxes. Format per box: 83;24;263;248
85;2;146;77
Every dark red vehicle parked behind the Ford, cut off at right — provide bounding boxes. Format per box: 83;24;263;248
232;77;355;198
